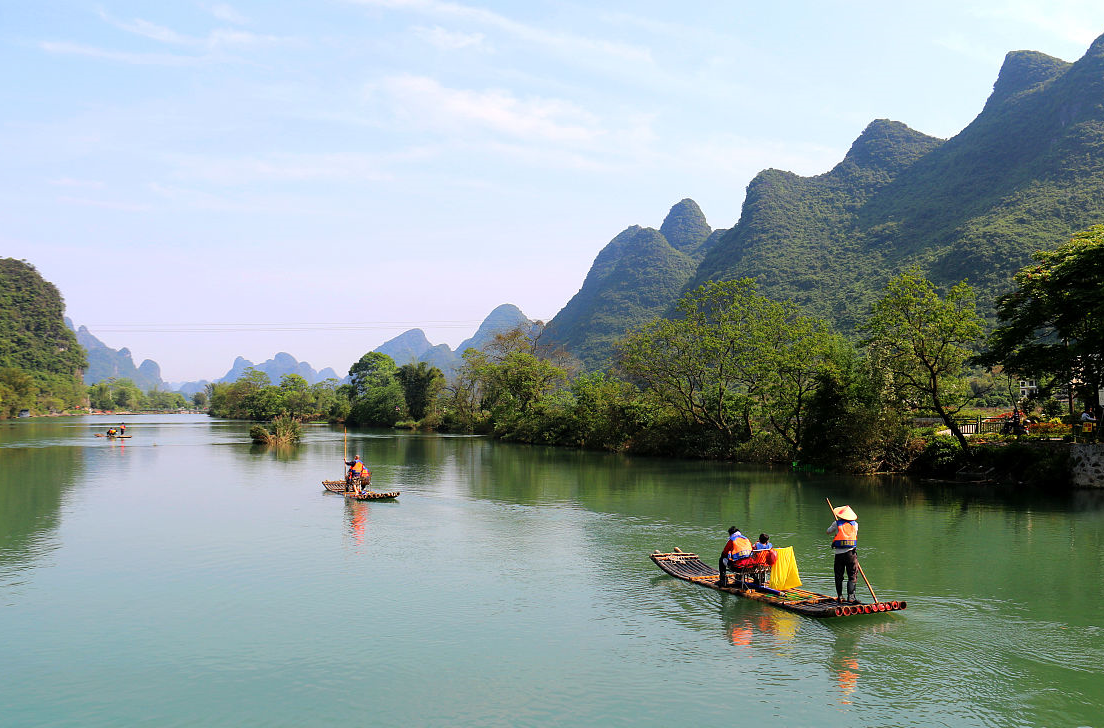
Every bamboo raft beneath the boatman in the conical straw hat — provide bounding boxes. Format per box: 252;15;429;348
650;548;906;619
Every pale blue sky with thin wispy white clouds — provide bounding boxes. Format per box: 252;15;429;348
0;0;1104;382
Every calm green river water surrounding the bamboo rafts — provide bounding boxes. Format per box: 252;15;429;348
0;415;1104;727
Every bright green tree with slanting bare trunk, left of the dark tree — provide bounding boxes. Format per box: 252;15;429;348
866;267;981;451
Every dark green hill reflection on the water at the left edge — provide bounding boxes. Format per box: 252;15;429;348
0;433;84;588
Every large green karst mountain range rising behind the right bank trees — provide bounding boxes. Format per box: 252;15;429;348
548;36;1104;367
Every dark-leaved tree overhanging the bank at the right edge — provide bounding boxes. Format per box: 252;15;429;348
978;225;1104;404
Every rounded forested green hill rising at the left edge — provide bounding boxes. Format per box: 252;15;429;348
0;257;87;416
